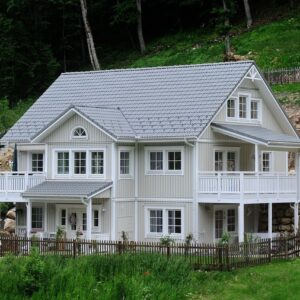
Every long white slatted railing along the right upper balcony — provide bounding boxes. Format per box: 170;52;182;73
198;172;297;195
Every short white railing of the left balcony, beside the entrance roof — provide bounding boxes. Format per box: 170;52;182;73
0;172;46;193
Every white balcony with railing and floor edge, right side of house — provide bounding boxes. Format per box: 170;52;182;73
197;172;297;204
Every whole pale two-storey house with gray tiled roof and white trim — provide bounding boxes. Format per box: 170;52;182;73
0;61;300;242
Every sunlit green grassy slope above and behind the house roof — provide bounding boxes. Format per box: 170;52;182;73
102;9;300;69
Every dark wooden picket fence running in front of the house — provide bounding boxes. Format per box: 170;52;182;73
0;236;300;270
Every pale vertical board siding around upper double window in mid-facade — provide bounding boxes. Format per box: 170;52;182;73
138;145;193;198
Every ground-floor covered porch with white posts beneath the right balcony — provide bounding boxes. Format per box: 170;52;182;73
199;203;299;243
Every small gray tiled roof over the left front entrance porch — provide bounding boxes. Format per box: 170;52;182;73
22;180;112;198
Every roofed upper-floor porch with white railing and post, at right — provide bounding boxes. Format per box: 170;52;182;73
197;123;300;204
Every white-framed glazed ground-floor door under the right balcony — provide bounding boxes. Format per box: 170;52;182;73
214;207;237;241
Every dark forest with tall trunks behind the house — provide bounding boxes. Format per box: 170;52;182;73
0;0;299;133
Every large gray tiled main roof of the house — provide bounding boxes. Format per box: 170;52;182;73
3;61;254;141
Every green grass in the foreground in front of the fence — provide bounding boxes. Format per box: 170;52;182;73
0;252;300;300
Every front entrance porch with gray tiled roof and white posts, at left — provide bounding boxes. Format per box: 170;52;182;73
16;181;112;240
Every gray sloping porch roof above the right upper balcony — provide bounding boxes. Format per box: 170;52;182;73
211;123;300;148
